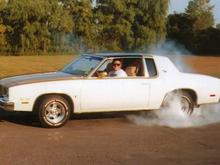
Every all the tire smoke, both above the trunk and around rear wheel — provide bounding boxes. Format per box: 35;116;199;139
127;41;220;128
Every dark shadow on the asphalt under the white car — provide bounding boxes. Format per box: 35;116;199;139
0;109;144;127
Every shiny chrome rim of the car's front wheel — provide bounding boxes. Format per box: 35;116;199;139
44;101;67;124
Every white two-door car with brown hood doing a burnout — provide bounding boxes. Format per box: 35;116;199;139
0;53;220;127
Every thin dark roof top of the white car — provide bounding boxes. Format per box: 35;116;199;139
83;53;153;58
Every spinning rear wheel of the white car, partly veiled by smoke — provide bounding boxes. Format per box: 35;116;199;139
162;91;194;116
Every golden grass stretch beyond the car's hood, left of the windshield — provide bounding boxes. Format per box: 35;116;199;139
0;55;74;78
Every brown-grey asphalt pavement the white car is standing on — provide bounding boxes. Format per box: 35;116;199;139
0;111;220;165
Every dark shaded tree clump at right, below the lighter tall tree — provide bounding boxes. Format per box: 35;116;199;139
167;13;220;55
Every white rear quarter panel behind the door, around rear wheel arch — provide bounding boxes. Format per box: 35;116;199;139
149;56;220;109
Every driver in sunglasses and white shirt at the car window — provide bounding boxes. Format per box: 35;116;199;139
108;59;127;77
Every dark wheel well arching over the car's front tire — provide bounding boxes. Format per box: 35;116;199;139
32;93;74;113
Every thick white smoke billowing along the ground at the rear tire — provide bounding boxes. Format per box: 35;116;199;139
127;95;220;128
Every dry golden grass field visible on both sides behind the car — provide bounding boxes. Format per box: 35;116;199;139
0;55;220;78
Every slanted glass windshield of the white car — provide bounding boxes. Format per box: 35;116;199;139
61;56;102;76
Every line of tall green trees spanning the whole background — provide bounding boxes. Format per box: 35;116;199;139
0;0;220;54
